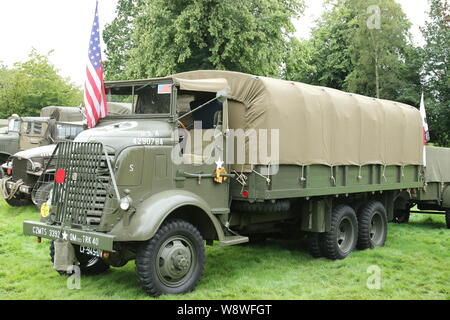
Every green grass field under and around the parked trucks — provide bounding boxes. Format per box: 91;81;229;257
0;201;450;300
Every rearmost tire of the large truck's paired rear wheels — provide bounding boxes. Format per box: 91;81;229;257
357;201;388;250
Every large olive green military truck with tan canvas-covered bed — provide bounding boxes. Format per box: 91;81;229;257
23;71;440;296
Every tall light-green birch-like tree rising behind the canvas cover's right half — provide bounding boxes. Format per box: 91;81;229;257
346;0;411;100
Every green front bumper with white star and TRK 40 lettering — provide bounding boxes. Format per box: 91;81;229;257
23;221;115;252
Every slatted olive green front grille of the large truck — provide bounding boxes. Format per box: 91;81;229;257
52;142;111;227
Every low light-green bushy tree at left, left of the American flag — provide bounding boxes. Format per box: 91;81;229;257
0;49;82;118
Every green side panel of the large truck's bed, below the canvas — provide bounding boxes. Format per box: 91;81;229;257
231;165;423;201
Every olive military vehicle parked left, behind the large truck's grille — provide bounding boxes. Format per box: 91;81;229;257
0;103;131;209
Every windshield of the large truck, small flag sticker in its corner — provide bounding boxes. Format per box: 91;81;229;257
107;83;172;115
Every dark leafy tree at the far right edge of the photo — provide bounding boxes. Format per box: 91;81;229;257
422;0;450;146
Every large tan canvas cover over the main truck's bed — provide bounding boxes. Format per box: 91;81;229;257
173;71;423;166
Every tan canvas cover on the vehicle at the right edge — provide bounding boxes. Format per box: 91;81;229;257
425;146;450;182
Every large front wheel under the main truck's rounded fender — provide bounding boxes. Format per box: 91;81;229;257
136;220;205;297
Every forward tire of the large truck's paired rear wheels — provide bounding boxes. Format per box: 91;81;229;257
320;205;358;260
